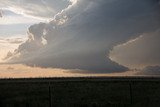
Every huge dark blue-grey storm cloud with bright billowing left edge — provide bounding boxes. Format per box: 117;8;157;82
4;0;160;72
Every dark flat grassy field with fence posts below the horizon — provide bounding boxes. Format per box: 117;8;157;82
0;77;160;107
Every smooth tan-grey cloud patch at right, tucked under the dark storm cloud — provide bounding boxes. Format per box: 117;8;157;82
110;29;160;68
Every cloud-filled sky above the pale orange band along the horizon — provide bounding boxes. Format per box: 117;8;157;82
0;0;160;77
